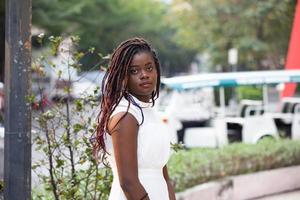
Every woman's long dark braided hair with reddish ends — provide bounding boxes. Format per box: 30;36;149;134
93;37;160;160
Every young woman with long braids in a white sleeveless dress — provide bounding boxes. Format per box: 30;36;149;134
94;38;175;200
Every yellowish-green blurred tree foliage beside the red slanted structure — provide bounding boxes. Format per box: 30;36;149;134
168;0;296;70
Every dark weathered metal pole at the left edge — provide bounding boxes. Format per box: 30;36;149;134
4;0;31;200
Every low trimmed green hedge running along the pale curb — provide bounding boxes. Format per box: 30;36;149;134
168;139;300;192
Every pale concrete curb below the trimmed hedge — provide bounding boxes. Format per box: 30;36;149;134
176;165;300;200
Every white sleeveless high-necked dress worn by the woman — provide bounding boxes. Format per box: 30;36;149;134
105;97;170;200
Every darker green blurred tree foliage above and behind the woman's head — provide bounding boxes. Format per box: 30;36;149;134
33;0;196;75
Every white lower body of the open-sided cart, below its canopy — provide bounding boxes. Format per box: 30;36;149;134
185;100;278;147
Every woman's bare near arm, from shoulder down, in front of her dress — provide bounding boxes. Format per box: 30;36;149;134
108;113;149;200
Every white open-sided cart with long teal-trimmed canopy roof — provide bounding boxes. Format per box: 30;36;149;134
162;70;300;147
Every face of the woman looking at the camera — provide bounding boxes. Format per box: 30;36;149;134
128;52;157;102
